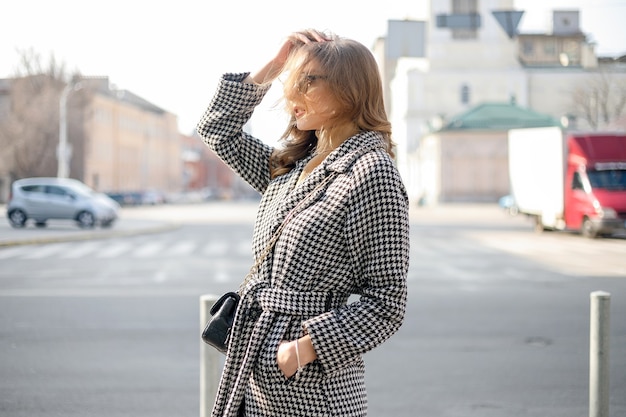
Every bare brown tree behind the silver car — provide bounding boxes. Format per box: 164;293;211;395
0;50;83;178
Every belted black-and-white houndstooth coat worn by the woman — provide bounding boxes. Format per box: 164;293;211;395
197;74;409;417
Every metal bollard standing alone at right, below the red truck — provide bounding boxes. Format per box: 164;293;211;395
589;291;611;417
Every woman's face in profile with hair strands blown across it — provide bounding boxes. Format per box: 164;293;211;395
289;61;339;130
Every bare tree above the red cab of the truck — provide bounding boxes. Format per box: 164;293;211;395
572;68;626;130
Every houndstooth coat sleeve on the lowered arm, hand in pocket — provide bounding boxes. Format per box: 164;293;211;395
303;153;409;374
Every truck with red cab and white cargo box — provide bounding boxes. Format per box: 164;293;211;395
508;127;626;237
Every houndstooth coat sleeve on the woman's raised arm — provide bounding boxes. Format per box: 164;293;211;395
196;73;272;193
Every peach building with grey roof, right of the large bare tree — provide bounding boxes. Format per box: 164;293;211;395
79;77;183;192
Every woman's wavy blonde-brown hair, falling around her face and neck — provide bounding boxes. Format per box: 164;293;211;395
270;30;394;178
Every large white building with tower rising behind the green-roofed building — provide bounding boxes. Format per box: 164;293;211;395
374;0;626;202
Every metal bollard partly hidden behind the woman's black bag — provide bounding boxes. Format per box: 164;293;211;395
198;295;223;417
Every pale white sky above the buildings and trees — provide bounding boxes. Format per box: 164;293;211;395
0;0;626;134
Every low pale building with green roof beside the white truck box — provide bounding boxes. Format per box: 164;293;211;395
413;103;560;204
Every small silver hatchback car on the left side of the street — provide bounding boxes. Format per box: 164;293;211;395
7;178;120;228
